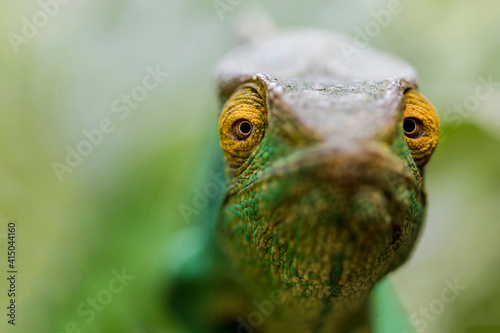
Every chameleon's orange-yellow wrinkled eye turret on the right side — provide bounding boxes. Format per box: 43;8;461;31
403;89;439;168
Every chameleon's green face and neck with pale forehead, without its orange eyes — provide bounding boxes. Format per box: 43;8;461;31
173;29;436;333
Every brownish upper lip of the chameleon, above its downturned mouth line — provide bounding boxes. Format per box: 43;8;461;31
243;139;416;192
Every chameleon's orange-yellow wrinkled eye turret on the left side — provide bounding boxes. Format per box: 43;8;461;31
219;83;267;168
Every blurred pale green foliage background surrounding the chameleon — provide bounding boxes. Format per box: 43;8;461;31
0;0;500;333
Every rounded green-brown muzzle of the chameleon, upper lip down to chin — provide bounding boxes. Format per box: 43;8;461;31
217;142;423;299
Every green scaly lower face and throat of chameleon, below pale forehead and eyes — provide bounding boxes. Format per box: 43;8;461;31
217;83;425;332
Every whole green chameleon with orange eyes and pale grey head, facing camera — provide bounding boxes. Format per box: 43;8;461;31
171;30;439;333
